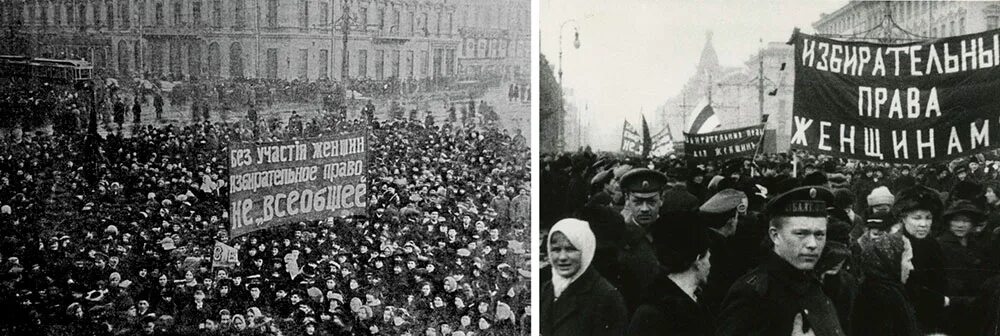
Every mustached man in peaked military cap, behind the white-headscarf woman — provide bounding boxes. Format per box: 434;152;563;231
618;168;667;313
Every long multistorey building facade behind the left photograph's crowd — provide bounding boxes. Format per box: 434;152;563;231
0;0;530;81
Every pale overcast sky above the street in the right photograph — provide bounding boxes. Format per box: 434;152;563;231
539;0;847;150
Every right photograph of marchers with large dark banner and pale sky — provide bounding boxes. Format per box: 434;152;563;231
533;0;1000;336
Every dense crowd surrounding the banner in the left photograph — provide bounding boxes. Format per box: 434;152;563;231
0;84;531;335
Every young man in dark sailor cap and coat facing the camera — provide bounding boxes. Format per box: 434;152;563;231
716;186;844;335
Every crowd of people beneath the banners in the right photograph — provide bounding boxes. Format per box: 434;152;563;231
539;149;1000;335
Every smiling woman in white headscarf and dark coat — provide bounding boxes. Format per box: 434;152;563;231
540;218;628;336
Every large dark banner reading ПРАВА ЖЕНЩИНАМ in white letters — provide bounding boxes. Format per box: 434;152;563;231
790;30;1000;163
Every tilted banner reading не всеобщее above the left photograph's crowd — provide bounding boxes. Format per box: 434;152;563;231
229;132;368;237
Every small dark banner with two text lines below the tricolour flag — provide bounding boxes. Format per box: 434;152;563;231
684;124;764;161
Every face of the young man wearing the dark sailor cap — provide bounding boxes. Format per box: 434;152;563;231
769;217;826;270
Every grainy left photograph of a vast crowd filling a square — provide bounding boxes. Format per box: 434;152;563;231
0;0;537;336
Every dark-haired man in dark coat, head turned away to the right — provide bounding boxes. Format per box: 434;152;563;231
628;214;715;336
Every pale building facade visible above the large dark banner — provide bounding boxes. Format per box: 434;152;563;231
813;0;1000;41
